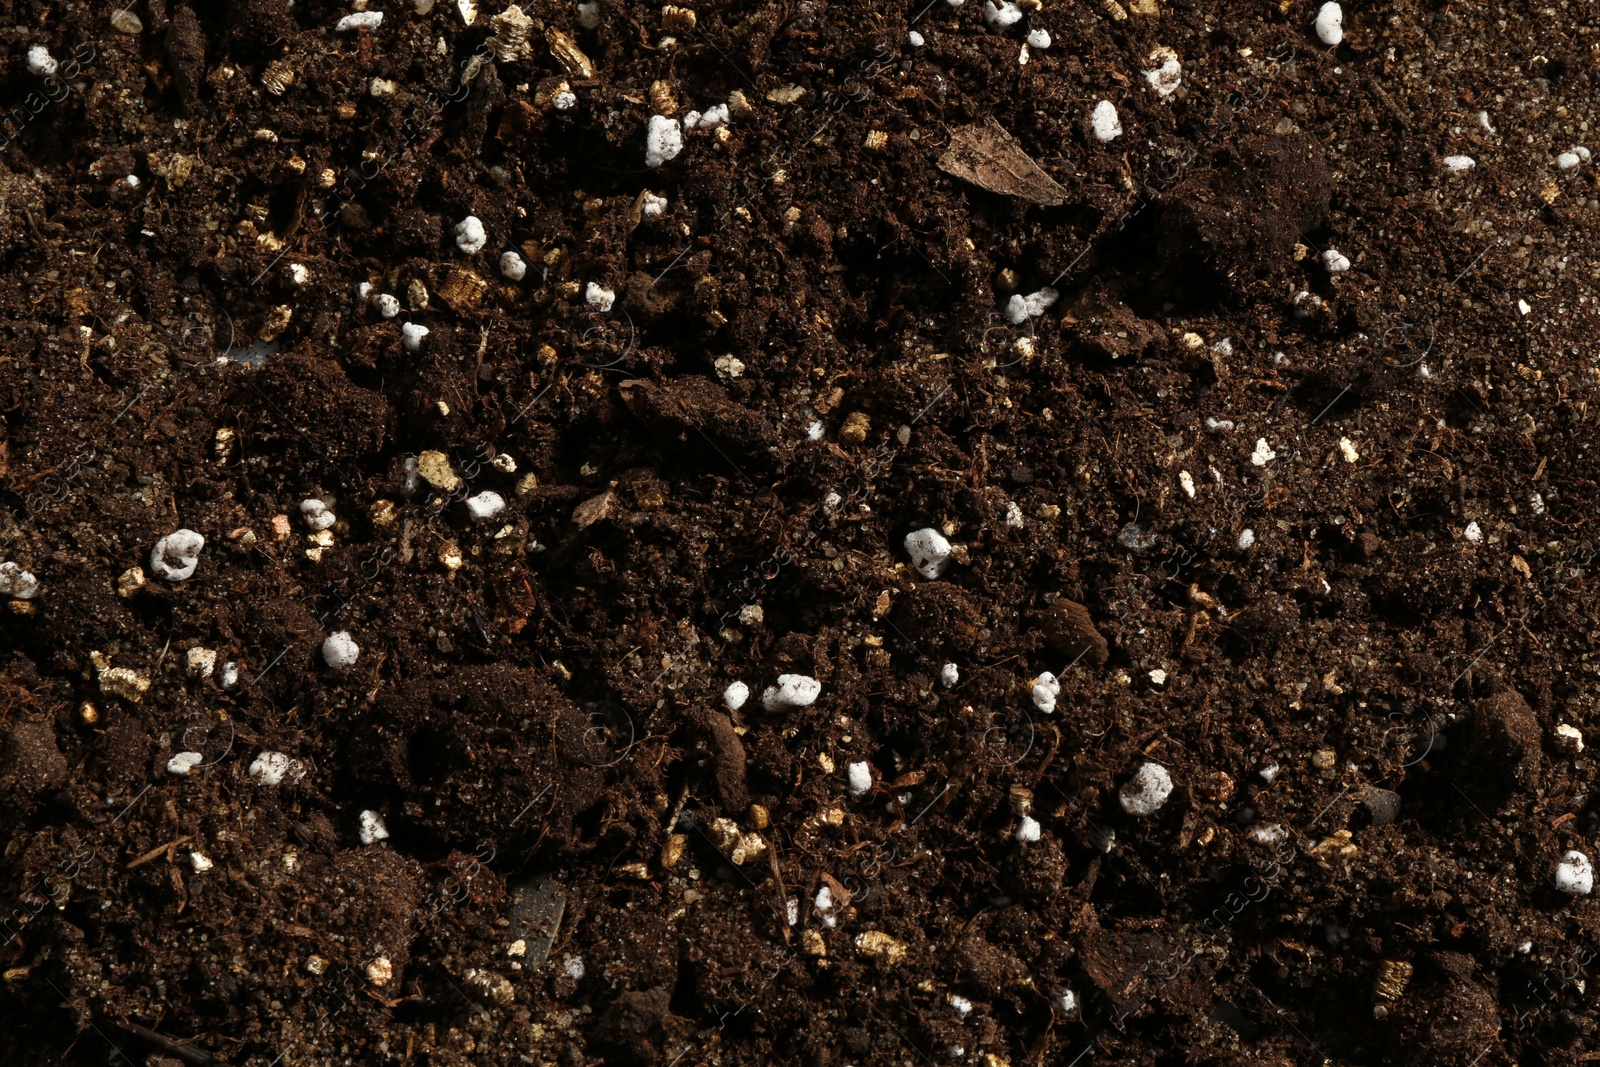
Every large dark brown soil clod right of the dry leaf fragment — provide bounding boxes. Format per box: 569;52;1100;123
1157;134;1333;301
